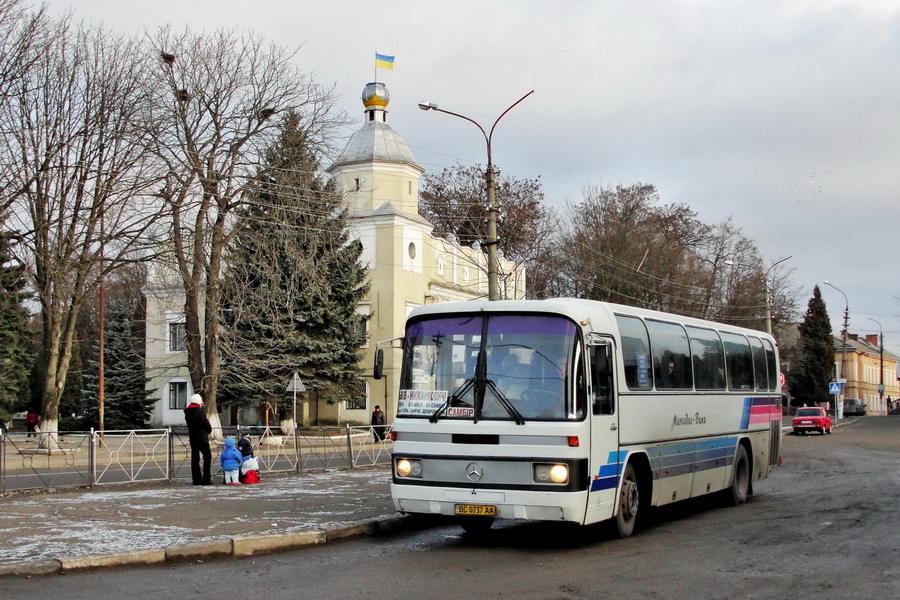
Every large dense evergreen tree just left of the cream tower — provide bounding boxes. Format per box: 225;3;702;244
220;113;369;420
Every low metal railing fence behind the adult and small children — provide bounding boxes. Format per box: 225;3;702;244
0;426;392;493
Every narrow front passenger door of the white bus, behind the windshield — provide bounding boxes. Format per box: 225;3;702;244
587;338;624;522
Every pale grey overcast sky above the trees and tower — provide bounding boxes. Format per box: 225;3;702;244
49;0;900;353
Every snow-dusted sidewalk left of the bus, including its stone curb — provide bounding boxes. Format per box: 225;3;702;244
0;467;411;576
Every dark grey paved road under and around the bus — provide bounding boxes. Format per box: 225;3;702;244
3;417;900;600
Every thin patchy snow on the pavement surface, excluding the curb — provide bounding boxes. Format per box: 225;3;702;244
0;469;393;564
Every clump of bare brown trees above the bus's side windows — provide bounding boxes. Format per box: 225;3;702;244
556;184;796;330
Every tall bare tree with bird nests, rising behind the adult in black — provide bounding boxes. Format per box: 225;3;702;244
151;28;343;427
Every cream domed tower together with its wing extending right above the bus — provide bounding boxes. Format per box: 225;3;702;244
320;82;525;423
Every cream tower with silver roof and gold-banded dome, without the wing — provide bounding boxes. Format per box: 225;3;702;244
328;82;434;422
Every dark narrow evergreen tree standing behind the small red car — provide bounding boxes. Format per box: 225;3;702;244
789;286;834;406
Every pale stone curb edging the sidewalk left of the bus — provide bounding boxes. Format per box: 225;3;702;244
0;514;433;579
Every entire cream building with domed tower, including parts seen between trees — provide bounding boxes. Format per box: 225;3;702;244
146;82;525;426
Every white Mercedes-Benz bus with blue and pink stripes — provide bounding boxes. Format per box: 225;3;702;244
376;299;781;537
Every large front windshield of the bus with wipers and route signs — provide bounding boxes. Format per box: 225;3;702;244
397;313;584;424
